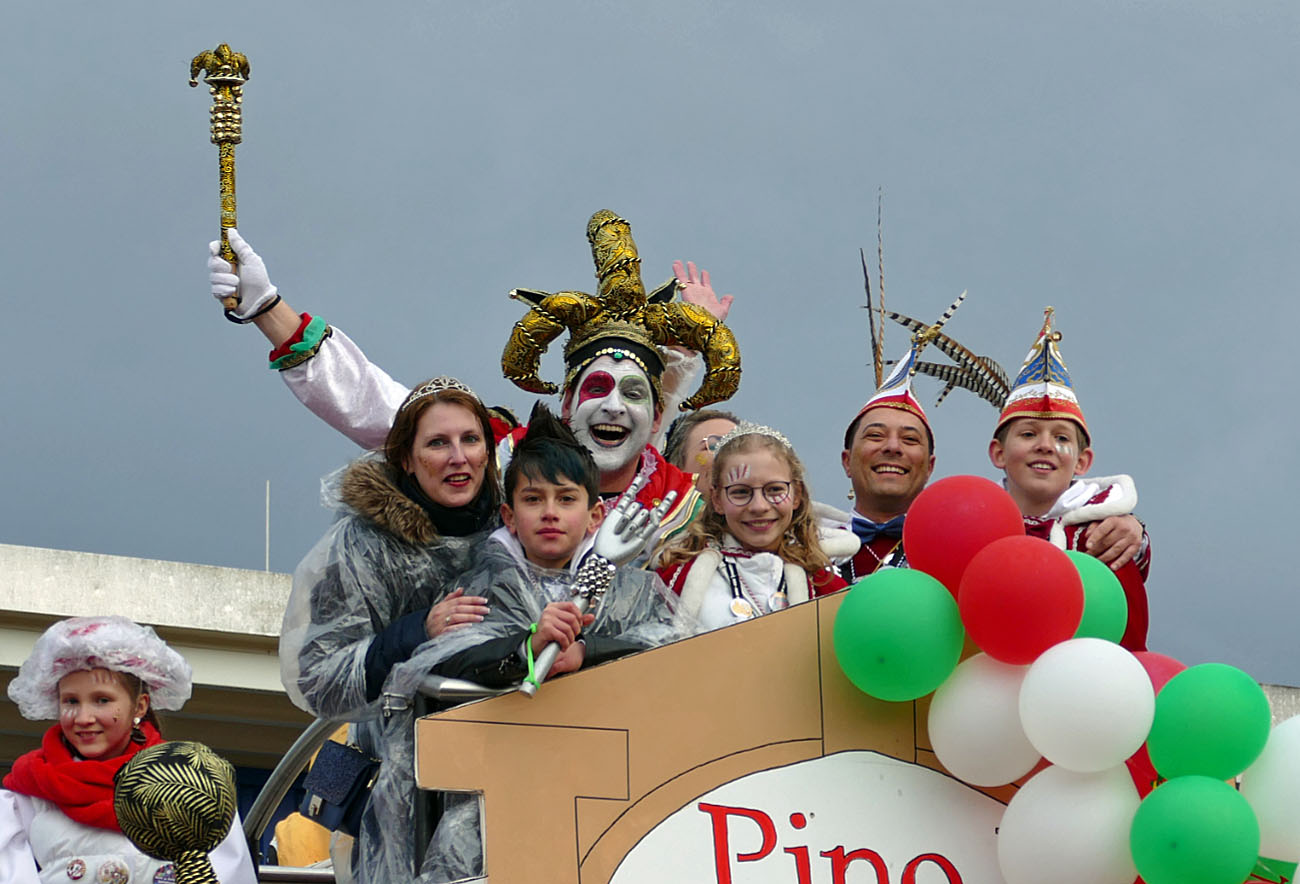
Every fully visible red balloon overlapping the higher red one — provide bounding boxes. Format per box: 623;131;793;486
961;538;1083;666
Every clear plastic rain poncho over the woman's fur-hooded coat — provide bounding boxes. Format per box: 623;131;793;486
280;458;497;883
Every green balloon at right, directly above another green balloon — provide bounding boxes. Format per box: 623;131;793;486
1147;663;1273;780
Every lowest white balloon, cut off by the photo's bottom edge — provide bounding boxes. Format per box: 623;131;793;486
997;764;1139;884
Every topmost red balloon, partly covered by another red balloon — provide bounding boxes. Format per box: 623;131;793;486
902;476;1024;595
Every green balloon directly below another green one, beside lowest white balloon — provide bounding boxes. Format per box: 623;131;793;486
1130;774;1260;884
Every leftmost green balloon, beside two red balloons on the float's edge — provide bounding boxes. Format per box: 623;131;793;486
832;568;966;702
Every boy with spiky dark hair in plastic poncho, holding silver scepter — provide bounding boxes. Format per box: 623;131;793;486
434;404;679;688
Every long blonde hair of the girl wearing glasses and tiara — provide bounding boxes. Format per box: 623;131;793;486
655;424;831;572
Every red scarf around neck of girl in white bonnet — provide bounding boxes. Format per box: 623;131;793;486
4;722;163;832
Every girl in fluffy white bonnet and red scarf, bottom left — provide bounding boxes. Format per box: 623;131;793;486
0;616;257;884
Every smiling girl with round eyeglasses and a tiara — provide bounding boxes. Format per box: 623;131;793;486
658;421;858;631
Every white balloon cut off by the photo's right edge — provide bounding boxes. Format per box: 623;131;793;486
1242;715;1300;862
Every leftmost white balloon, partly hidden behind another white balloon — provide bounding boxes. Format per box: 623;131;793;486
928;654;1040;785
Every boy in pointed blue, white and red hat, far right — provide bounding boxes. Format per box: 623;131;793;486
988;307;1151;651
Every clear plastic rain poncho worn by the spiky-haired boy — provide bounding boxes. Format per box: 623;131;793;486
382;528;693;884
